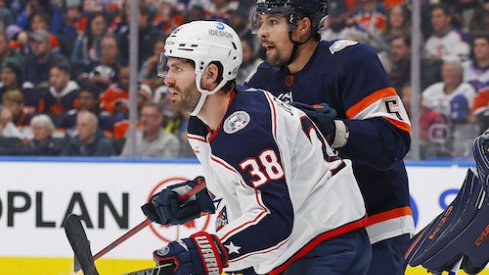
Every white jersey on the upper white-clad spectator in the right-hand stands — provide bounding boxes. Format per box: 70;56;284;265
425;30;470;61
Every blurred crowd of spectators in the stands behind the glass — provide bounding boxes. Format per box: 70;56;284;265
0;0;489;161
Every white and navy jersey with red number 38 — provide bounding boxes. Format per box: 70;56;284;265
188;87;366;274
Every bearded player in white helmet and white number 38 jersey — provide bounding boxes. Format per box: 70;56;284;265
143;21;371;275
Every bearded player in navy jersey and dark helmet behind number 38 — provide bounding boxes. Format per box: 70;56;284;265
247;0;414;275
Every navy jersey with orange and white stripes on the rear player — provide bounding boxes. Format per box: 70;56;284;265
247;40;414;243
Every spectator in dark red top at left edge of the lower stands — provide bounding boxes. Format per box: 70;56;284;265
2;90;34;127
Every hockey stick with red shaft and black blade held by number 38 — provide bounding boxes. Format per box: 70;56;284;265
64;180;205;275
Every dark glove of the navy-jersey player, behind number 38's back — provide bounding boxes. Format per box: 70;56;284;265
291;102;338;144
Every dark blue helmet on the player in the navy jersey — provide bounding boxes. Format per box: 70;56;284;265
252;0;328;33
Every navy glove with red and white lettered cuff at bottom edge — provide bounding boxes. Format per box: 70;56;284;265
153;231;228;275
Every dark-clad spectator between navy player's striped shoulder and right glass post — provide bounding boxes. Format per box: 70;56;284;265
388;36;411;96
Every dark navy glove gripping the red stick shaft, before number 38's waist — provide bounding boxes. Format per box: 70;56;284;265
141;177;215;225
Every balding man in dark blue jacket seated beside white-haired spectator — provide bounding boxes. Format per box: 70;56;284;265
62;111;115;156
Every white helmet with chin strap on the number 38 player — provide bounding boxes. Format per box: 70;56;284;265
158;21;243;116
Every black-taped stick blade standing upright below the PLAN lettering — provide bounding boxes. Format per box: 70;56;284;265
64;214;99;275
